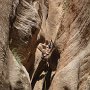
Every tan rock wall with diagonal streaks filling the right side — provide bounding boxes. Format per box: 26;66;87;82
50;0;90;90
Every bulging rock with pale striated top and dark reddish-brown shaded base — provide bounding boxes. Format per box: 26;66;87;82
10;0;40;76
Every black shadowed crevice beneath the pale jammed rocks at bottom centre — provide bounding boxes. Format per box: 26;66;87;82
31;48;60;90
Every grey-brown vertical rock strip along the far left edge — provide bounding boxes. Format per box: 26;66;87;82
0;0;12;90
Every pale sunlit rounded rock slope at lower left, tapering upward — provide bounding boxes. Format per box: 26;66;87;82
8;50;31;90
